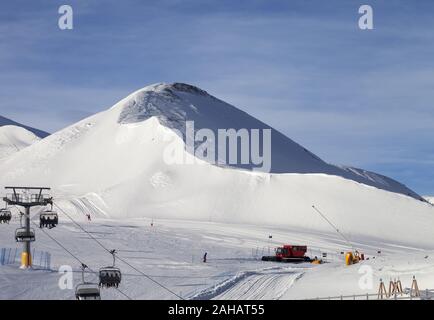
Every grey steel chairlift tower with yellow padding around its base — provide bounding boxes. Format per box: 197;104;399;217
3;187;53;269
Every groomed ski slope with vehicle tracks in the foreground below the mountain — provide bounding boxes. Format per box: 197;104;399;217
0;210;434;300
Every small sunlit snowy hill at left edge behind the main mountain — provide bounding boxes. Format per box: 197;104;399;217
0;125;40;161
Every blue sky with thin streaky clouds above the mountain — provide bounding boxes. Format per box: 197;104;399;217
0;0;434;194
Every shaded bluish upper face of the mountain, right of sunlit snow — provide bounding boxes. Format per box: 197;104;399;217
110;83;425;201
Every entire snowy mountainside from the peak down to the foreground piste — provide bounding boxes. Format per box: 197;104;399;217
0;85;434;299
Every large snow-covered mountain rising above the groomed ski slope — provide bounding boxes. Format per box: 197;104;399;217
0;85;434;248
